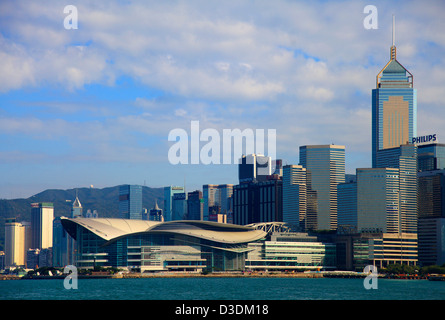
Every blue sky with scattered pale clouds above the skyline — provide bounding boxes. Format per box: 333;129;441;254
0;0;445;199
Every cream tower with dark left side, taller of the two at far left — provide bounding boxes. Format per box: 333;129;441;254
31;202;54;250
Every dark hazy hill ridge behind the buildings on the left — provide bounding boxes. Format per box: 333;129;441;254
0;186;164;250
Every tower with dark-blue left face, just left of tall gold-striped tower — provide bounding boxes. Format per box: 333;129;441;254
283;165;307;230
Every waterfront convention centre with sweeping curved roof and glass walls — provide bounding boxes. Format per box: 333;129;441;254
62;218;266;272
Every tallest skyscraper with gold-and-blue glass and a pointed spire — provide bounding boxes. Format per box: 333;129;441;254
372;17;417;168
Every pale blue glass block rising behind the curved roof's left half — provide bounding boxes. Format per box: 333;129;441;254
119;184;142;220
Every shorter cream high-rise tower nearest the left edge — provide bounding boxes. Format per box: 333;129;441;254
5;218;25;267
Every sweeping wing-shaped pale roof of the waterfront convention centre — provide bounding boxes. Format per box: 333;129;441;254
62;218;267;244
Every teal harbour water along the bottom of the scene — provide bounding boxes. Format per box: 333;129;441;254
0;278;445;300
